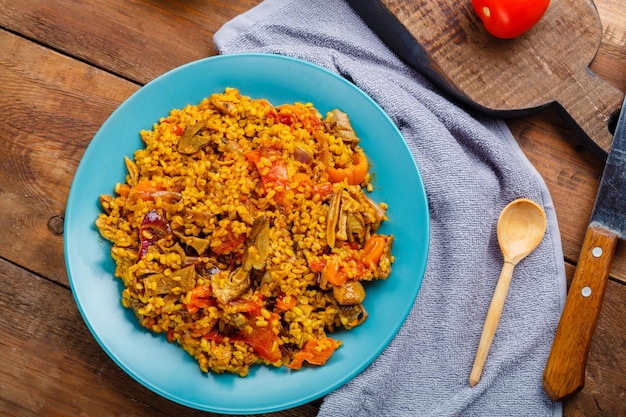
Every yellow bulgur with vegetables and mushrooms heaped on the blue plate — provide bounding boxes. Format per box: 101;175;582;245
96;88;393;376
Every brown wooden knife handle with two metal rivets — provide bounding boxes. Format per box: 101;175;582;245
543;226;618;401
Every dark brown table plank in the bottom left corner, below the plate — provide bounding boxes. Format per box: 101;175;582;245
0;260;318;417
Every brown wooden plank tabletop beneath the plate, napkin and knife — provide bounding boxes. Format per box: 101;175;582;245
0;0;626;417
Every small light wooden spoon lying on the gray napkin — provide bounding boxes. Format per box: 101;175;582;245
470;198;547;387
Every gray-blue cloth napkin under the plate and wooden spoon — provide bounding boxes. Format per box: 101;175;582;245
214;0;566;417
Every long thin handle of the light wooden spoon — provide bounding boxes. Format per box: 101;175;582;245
470;262;515;387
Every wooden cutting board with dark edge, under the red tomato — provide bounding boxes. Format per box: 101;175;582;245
348;0;624;158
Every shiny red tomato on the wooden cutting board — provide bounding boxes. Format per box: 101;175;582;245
472;0;550;39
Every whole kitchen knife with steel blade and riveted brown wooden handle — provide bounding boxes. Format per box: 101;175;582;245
543;96;626;401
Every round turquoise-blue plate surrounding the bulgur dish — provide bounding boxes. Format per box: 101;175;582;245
65;54;429;414
